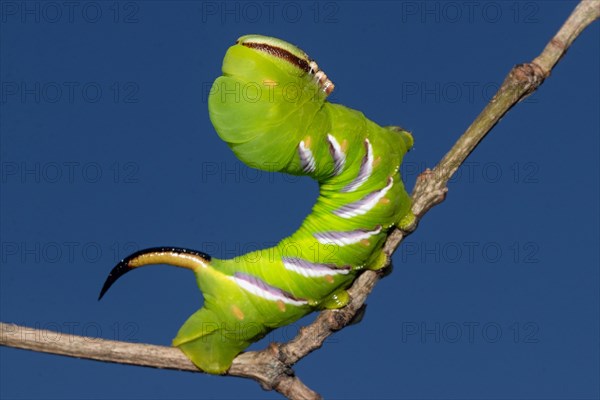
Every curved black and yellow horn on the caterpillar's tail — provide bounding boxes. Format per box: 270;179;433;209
98;247;211;300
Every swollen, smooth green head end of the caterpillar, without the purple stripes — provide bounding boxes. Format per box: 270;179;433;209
208;35;334;171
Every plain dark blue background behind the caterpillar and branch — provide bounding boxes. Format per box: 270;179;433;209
0;1;600;399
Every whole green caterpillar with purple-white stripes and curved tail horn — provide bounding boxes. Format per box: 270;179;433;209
100;35;414;374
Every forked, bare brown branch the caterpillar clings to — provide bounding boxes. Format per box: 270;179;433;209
0;0;600;399
